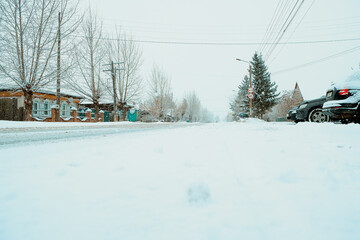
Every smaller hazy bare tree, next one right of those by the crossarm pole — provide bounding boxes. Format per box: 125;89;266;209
147;66;173;120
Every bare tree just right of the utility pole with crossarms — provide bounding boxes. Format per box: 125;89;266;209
107;29;142;120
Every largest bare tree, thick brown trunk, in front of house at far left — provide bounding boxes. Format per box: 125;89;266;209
0;0;59;120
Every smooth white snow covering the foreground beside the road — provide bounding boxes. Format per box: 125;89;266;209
0;120;360;240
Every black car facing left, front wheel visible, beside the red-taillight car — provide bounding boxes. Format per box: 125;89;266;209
287;96;330;123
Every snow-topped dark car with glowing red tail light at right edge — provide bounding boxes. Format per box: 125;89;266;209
323;72;360;123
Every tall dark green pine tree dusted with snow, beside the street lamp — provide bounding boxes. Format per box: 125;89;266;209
251;53;280;118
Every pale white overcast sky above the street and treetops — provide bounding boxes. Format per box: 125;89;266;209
81;0;360;118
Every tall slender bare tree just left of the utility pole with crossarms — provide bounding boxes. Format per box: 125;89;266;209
69;9;105;121
